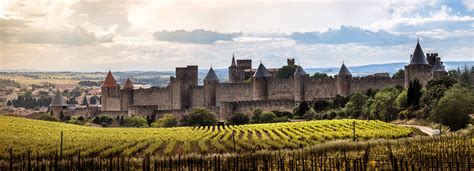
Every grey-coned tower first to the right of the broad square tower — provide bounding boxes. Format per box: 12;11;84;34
204;67;219;106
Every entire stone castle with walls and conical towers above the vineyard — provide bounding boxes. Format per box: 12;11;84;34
51;42;447;119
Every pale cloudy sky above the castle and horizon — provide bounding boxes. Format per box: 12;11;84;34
0;0;474;71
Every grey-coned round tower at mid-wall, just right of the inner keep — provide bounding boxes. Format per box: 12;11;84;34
252;62;272;100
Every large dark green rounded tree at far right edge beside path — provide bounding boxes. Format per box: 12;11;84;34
432;84;474;131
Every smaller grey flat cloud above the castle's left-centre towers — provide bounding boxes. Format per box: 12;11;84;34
153;29;241;44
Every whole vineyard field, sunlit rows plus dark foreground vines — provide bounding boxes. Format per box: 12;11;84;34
0;116;472;170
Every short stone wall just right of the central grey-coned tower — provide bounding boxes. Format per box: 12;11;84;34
267;78;294;100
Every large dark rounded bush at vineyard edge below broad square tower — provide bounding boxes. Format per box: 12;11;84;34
181;108;217;126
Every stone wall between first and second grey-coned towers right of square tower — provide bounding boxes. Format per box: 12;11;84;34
216;83;252;104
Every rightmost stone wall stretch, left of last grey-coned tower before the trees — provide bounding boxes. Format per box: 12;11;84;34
304;78;337;101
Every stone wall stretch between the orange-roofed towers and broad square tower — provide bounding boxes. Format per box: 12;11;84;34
133;87;171;109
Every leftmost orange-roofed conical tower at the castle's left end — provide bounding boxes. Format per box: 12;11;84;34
100;70;121;111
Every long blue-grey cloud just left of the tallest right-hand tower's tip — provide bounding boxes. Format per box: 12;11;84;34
290;26;412;46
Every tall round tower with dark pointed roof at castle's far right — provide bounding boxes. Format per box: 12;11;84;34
405;40;432;87
